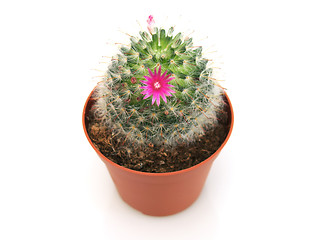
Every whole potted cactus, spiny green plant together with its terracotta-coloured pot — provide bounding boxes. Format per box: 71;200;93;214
83;16;233;216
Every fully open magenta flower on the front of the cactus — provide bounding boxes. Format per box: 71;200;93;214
140;65;175;106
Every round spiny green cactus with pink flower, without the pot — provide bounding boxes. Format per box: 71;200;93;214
92;16;225;149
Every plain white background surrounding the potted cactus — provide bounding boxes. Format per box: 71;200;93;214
0;0;320;240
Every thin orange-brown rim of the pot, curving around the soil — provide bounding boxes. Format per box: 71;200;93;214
82;88;234;177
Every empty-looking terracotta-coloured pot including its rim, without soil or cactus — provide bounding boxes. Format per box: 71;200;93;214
82;87;234;216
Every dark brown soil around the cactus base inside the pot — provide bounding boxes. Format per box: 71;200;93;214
86;100;230;173
